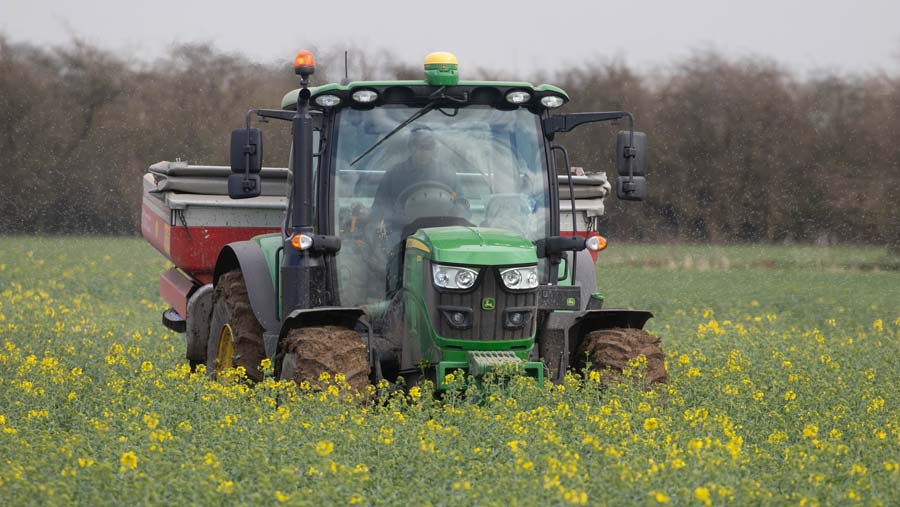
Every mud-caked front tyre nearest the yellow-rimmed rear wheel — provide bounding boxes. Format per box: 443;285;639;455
275;326;370;393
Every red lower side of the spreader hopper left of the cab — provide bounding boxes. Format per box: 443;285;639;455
141;205;279;283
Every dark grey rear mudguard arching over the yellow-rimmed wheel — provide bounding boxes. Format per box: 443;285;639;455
213;241;281;334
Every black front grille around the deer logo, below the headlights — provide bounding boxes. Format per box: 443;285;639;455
425;263;537;341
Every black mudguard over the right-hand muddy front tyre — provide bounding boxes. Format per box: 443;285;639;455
538;308;653;382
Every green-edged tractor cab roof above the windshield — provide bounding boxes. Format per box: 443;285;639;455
281;80;569;110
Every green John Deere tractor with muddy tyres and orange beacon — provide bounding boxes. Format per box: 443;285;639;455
145;51;666;390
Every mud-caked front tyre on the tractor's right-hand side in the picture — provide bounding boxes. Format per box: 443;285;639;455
574;328;668;385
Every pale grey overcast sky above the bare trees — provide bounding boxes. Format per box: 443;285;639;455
0;0;900;78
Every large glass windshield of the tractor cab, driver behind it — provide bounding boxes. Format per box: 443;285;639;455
334;105;550;306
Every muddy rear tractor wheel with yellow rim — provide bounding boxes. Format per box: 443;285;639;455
206;271;266;382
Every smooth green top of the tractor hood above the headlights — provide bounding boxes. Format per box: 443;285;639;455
406;226;537;266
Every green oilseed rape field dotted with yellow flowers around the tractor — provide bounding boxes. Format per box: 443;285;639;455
0;237;900;506
